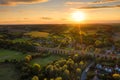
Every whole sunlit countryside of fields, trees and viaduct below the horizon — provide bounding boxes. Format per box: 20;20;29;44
0;24;120;80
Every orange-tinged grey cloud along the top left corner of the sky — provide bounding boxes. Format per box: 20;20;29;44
0;0;48;5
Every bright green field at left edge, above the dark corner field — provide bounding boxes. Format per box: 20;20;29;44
0;49;27;62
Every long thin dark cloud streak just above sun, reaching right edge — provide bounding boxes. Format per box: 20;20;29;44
78;5;120;9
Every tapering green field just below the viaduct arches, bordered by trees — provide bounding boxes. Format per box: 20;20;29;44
30;55;65;67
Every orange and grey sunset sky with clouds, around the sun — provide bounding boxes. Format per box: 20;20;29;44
0;0;120;24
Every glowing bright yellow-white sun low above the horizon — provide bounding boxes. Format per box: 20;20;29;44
71;11;85;22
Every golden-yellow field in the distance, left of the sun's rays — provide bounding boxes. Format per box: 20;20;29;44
25;31;49;37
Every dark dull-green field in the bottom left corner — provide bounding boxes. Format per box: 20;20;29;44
0;64;18;80
